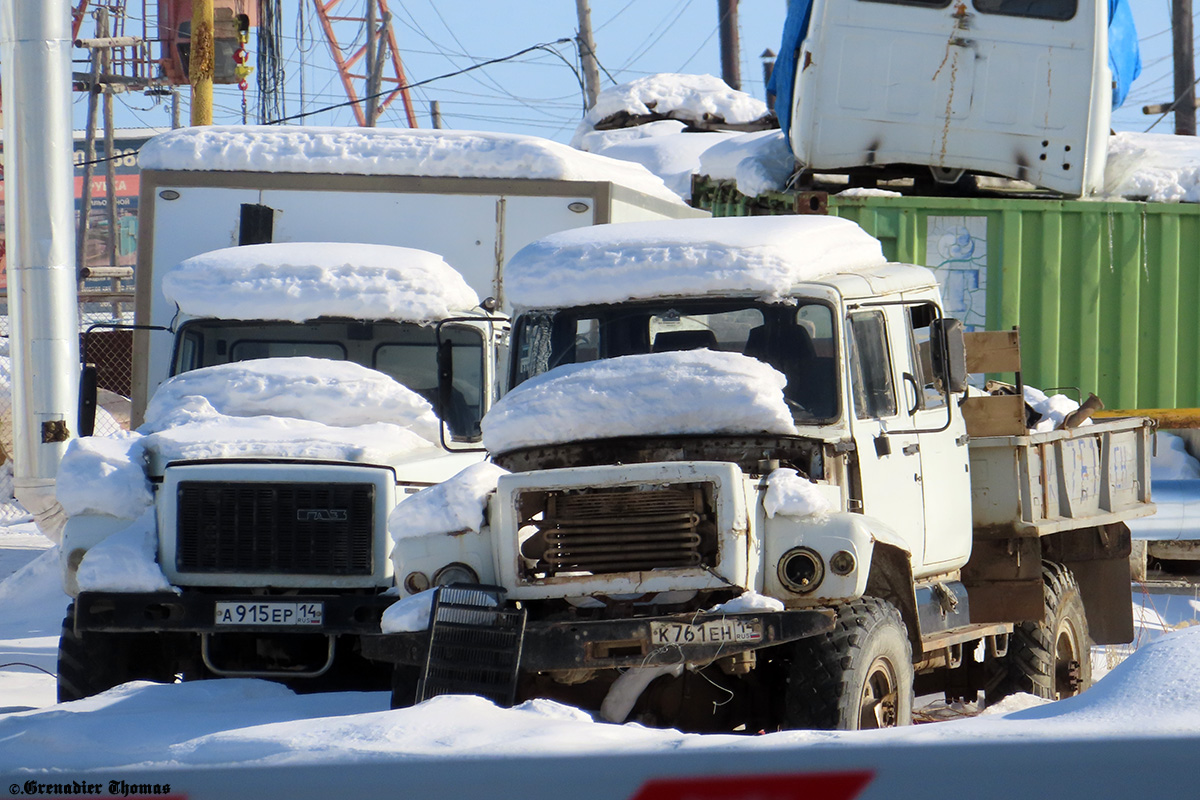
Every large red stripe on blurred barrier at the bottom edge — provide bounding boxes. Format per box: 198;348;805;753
630;772;875;800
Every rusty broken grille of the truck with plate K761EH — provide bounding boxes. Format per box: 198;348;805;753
522;485;716;577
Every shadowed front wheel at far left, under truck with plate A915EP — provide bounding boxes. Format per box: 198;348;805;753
58;604;175;703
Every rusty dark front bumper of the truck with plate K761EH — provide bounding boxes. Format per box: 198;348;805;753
361;609;834;672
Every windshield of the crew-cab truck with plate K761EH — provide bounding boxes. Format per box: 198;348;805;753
511;300;840;421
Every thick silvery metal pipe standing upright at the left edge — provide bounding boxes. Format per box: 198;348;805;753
0;0;79;541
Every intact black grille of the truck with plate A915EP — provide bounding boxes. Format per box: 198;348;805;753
175;481;376;575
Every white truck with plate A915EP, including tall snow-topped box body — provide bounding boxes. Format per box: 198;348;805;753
59;126;707;700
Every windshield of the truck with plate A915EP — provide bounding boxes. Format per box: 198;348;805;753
172;319;485;441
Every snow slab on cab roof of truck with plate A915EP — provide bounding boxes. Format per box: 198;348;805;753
162;242;479;323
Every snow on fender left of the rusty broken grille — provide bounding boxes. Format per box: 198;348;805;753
388;462;508;542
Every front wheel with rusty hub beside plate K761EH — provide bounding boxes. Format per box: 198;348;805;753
784;597;913;730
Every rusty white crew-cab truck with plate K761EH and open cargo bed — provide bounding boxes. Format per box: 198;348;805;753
364;217;1153;732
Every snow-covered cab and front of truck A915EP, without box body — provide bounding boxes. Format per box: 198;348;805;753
58;242;508;700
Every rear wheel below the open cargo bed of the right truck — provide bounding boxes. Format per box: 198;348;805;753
988;561;1092;703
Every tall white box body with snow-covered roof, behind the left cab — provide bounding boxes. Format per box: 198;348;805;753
124;126;707;426
